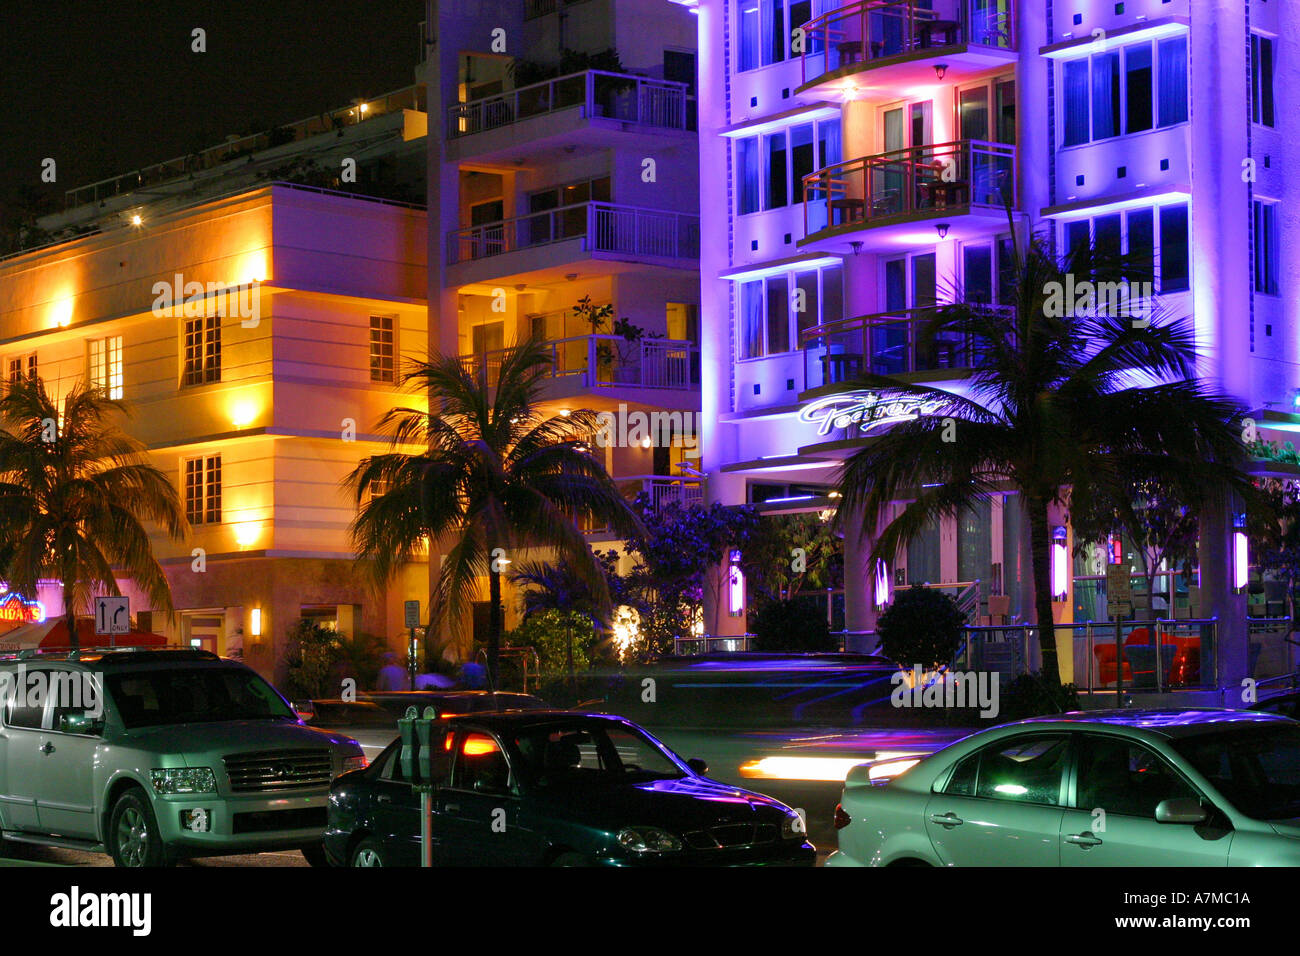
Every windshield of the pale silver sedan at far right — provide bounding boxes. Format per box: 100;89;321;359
1173;726;1300;819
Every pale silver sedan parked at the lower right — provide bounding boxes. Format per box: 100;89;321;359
827;709;1300;866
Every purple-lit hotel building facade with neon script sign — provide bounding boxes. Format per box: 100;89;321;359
696;0;1300;685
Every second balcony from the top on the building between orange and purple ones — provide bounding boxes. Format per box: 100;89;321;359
447;203;699;285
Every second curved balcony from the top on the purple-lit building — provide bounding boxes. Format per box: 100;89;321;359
798;139;1017;251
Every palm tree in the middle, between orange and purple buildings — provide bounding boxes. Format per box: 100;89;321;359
346;341;641;685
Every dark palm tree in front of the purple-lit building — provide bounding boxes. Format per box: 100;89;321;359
839;227;1249;683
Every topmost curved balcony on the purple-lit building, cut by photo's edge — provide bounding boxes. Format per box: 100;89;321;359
798;0;1015;95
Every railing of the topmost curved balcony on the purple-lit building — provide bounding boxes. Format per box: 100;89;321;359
802;0;1015;83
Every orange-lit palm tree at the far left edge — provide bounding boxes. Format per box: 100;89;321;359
0;377;189;648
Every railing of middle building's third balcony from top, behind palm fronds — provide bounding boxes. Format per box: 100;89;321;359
460;336;699;389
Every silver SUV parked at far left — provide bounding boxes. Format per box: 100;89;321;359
0;650;365;866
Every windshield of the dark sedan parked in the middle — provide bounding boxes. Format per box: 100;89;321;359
514;722;686;787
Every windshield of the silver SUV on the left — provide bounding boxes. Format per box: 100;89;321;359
104;667;298;728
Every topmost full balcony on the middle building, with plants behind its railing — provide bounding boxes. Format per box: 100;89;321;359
447;70;694;163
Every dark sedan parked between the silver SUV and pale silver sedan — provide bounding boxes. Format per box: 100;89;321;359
325;711;816;866
